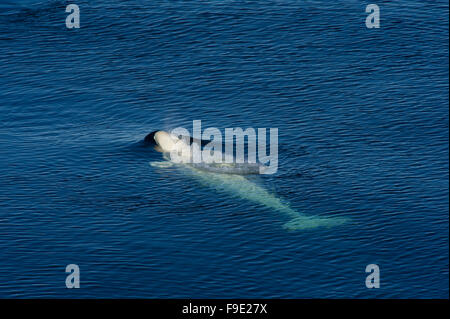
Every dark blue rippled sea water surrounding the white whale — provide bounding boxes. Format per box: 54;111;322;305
0;0;449;298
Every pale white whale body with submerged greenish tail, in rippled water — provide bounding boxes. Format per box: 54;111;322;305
150;131;348;230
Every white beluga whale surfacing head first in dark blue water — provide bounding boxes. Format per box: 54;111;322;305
145;131;349;231
